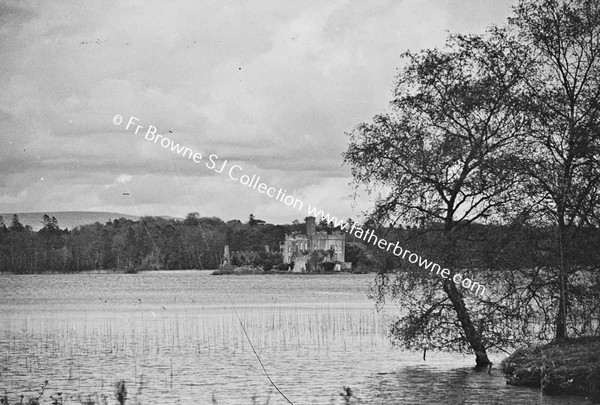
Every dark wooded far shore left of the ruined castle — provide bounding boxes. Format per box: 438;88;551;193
0;213;290;273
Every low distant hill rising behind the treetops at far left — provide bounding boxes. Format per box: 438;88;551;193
0;211;139;231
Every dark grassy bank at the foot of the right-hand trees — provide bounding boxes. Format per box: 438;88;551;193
502;338;600;403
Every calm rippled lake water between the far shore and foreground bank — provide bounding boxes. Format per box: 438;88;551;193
0;272;588;404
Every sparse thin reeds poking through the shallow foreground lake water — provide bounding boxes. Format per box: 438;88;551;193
0;303;380;405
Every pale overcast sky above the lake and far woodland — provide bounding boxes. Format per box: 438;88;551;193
0;0;514;223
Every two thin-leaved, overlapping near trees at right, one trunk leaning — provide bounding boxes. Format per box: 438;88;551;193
345;0;600;366
